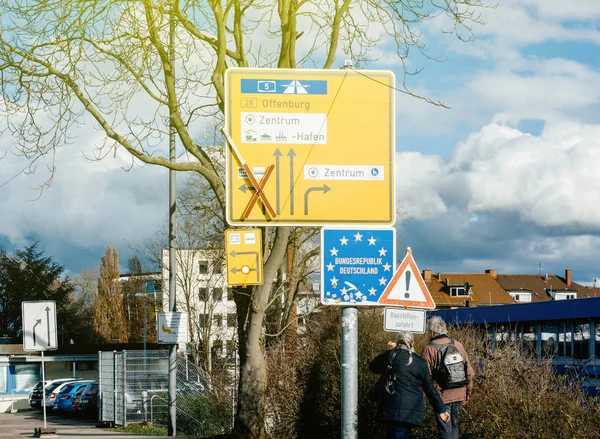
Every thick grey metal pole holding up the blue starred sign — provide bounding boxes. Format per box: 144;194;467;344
340;306;358;439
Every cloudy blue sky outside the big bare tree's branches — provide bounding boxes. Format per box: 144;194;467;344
0;0;600;284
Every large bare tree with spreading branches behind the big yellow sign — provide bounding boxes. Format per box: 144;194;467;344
0;0;481;438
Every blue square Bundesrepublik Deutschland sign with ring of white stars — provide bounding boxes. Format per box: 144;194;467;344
321;227;396;306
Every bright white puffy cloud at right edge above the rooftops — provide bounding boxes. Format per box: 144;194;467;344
450;123;600;230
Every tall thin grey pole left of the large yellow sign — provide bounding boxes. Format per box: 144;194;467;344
167;11;177;436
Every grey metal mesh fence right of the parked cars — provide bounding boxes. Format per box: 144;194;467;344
98;350;233;436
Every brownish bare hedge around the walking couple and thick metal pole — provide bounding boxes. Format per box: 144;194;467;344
267;308;600;439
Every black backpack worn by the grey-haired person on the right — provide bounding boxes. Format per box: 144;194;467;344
429;339;469;390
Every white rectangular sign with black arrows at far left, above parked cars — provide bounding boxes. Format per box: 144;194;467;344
21;300;58;351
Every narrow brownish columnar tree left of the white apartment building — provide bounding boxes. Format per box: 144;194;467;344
94;247;128;343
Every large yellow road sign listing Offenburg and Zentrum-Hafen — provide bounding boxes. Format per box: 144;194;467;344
225;68;396;225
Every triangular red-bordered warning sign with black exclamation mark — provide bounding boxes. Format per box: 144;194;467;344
379;249;435;309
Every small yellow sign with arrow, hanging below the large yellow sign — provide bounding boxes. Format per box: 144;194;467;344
225;229;263;285
